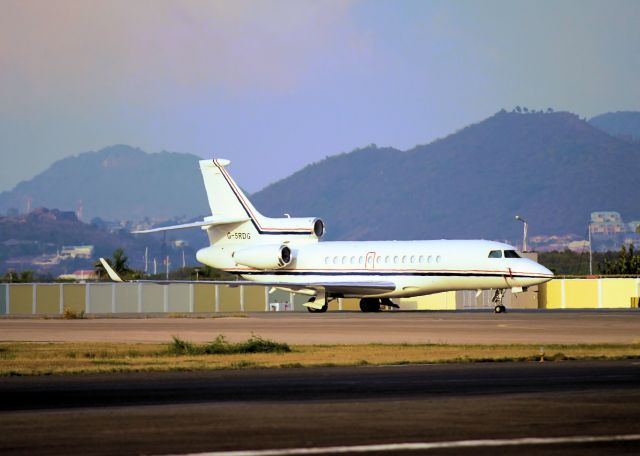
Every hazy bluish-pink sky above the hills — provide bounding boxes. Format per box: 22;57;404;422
0;0;640;192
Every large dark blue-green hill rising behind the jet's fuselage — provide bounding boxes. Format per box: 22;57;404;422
252;111;640;240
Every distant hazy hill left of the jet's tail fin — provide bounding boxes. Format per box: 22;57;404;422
0;145;208;221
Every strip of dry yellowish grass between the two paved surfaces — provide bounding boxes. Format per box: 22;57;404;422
0;342;640;376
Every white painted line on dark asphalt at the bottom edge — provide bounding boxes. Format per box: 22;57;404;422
164;434;640;456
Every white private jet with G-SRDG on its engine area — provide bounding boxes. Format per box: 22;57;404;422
101;159;553;313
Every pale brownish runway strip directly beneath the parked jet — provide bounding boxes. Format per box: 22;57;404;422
0;309;640;344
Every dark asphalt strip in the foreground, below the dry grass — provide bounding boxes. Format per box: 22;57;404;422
0;361;640;455
